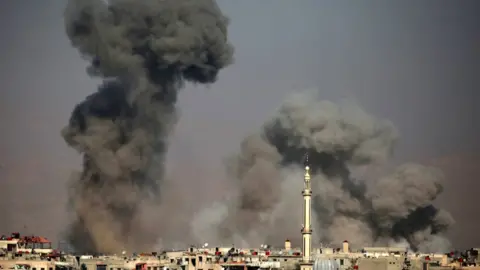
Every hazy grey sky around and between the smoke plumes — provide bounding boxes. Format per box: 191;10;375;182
0;0;480;249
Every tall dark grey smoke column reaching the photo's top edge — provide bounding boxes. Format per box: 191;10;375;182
62;0;233;252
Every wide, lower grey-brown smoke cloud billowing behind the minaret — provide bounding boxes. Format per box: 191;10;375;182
194;93;453;251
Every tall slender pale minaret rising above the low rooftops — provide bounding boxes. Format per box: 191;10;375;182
300;156;313;270
